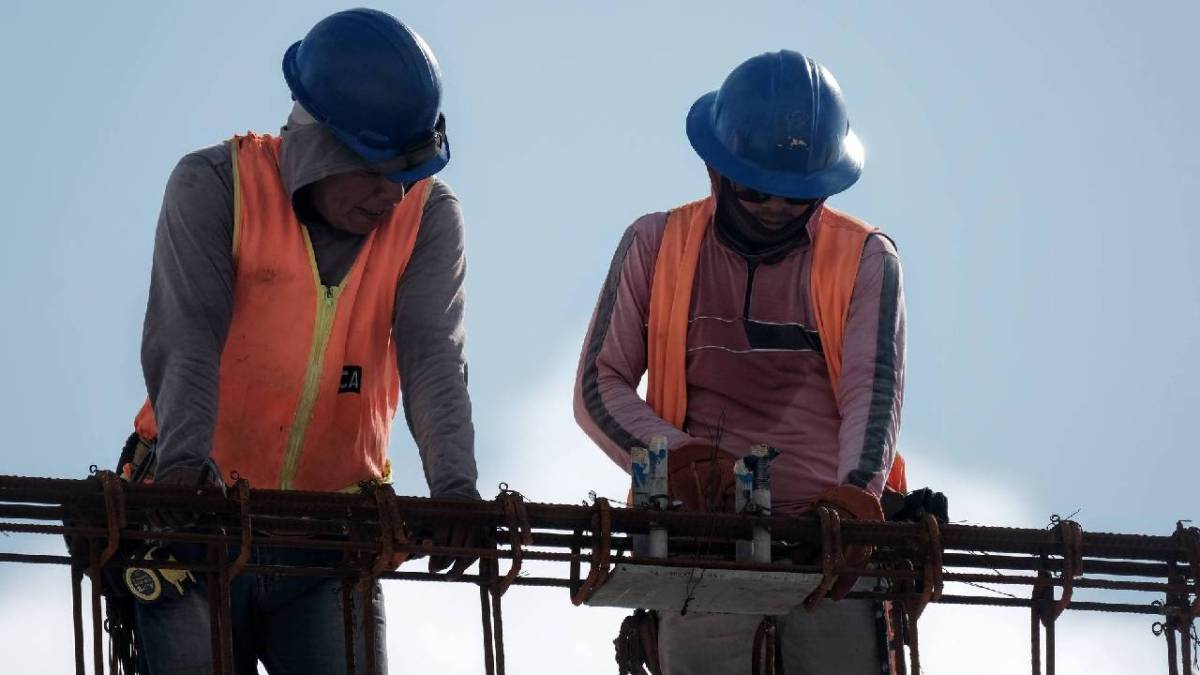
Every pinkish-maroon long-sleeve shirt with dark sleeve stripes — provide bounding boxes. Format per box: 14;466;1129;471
575;207;905;514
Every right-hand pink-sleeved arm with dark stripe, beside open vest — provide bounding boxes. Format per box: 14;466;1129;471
838;235;905;497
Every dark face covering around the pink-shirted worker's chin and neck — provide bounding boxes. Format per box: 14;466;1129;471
713;178;824;264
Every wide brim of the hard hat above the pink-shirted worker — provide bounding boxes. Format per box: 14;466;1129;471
688;91;863;199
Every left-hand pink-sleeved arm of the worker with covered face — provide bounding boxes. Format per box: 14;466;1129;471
575;213;700;471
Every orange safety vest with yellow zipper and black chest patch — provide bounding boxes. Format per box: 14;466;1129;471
134;133;430;491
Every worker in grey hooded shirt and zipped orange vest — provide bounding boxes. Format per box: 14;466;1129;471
129;10;479;675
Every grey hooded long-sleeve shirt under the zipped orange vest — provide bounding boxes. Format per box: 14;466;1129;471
142;119;479;498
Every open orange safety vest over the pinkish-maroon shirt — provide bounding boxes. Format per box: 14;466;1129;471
646;197;908;492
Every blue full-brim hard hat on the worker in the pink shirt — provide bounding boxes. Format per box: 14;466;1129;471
688;49;863;198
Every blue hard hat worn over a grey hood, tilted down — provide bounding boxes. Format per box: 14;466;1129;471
283;10;450;181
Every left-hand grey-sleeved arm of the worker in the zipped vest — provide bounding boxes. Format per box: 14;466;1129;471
142;145;233;482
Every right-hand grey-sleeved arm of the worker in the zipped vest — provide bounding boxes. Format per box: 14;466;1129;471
392;180;479;498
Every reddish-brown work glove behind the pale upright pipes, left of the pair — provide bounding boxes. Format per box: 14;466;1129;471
667;443;737;513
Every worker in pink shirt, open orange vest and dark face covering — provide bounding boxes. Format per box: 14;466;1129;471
575;50;905;675
